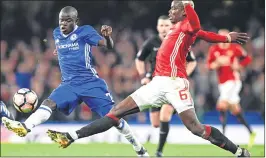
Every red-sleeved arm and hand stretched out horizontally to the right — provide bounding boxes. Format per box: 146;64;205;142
197;30;249;44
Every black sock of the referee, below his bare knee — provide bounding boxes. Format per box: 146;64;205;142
157;122;169;152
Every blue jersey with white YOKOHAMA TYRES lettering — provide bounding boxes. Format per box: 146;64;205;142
53;25;103;83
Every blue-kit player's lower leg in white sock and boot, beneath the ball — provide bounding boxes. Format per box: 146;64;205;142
2;99;56;137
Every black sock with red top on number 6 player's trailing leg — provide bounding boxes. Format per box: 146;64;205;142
203;126;238;154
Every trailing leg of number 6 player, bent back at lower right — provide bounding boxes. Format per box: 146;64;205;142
179;108;250;157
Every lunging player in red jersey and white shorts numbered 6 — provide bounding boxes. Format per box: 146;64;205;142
49;0;250;157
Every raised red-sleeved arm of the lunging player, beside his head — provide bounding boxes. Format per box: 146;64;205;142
183;1;201;33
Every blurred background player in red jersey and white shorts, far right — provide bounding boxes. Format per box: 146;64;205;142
207;29;256;148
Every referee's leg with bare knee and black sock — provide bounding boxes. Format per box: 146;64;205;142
156;104;174;157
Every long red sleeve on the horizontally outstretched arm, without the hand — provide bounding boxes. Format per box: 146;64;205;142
197;30;227;43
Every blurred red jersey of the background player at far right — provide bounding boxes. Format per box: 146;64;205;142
207;44;251;83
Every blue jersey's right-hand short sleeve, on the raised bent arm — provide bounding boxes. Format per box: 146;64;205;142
84;25;103;46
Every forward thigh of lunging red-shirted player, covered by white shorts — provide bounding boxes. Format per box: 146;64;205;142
130;79;165;111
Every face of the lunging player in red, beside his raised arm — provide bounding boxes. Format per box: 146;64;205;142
169;1;185;24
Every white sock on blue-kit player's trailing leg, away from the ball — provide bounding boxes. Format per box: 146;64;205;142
116;119;142;151
